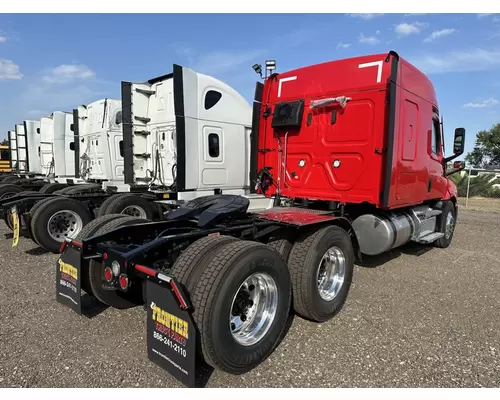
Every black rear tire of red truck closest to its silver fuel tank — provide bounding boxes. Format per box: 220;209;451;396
288;226;354;322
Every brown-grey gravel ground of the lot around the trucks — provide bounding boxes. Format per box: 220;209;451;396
0;207;500;387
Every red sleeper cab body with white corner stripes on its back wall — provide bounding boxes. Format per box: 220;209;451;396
257;53;440;208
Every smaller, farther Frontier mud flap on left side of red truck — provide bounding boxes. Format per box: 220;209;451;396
56;242;82;315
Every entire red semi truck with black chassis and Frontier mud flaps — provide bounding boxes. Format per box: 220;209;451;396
56;51;465;386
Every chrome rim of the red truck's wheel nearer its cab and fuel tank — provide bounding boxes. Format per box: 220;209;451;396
316;246;345;301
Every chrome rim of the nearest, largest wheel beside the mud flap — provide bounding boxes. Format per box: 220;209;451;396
229;272;278;346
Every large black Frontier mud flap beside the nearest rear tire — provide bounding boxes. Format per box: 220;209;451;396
146;280;198;388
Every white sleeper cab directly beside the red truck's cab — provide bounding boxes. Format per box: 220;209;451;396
122;65;268;208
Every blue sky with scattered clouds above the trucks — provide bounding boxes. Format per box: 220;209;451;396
0;14;500;157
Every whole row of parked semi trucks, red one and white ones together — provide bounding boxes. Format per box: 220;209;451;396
0;51;465;386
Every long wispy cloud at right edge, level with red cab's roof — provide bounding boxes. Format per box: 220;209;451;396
408;48;500;73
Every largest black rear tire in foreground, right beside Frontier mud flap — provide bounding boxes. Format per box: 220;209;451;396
191;240;291;375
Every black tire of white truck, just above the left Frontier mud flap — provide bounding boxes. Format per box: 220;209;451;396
31;197;93;254
